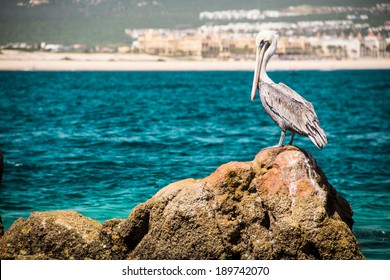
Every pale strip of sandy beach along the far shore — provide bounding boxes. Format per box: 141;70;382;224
0;50;390;71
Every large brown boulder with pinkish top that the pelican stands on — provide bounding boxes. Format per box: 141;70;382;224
124;147;363;259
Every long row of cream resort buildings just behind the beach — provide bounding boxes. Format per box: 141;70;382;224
127;25;390;60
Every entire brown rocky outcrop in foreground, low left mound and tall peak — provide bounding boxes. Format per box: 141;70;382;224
0;146;364;259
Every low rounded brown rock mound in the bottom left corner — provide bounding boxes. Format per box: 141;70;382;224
1;211;102;259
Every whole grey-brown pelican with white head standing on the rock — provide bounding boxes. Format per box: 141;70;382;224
251;30;328;149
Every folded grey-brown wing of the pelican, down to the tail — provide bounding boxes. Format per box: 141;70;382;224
262;83;327;147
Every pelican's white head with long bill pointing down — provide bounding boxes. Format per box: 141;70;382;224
251;30;279;100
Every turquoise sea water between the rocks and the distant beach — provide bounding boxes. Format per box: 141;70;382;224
0;71;390;259
